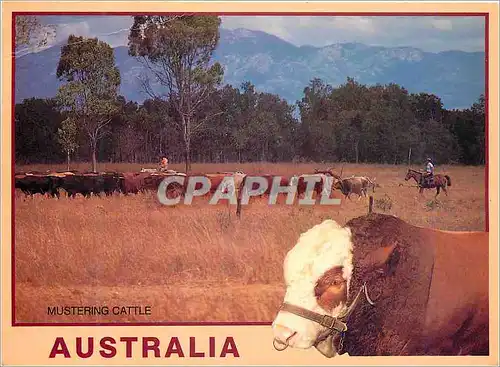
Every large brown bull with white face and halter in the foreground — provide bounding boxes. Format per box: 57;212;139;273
273;214;489;357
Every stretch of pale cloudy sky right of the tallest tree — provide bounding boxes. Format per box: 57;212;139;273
222;16;484;52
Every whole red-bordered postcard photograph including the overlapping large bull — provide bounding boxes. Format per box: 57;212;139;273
12;13;489;357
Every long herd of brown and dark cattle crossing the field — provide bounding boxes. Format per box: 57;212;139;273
15;170;376;198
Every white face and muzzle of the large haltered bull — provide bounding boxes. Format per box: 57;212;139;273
272;220;353;349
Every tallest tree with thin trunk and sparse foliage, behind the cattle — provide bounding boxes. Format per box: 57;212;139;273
128;15;223;171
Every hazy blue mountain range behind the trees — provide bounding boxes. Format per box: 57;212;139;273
15;28;485;109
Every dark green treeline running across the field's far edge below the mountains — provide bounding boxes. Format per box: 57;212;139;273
15;78;485;165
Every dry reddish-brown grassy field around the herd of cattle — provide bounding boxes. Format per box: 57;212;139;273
15;163;485;322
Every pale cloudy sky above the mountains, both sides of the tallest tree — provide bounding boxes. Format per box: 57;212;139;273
38;16;484;52
